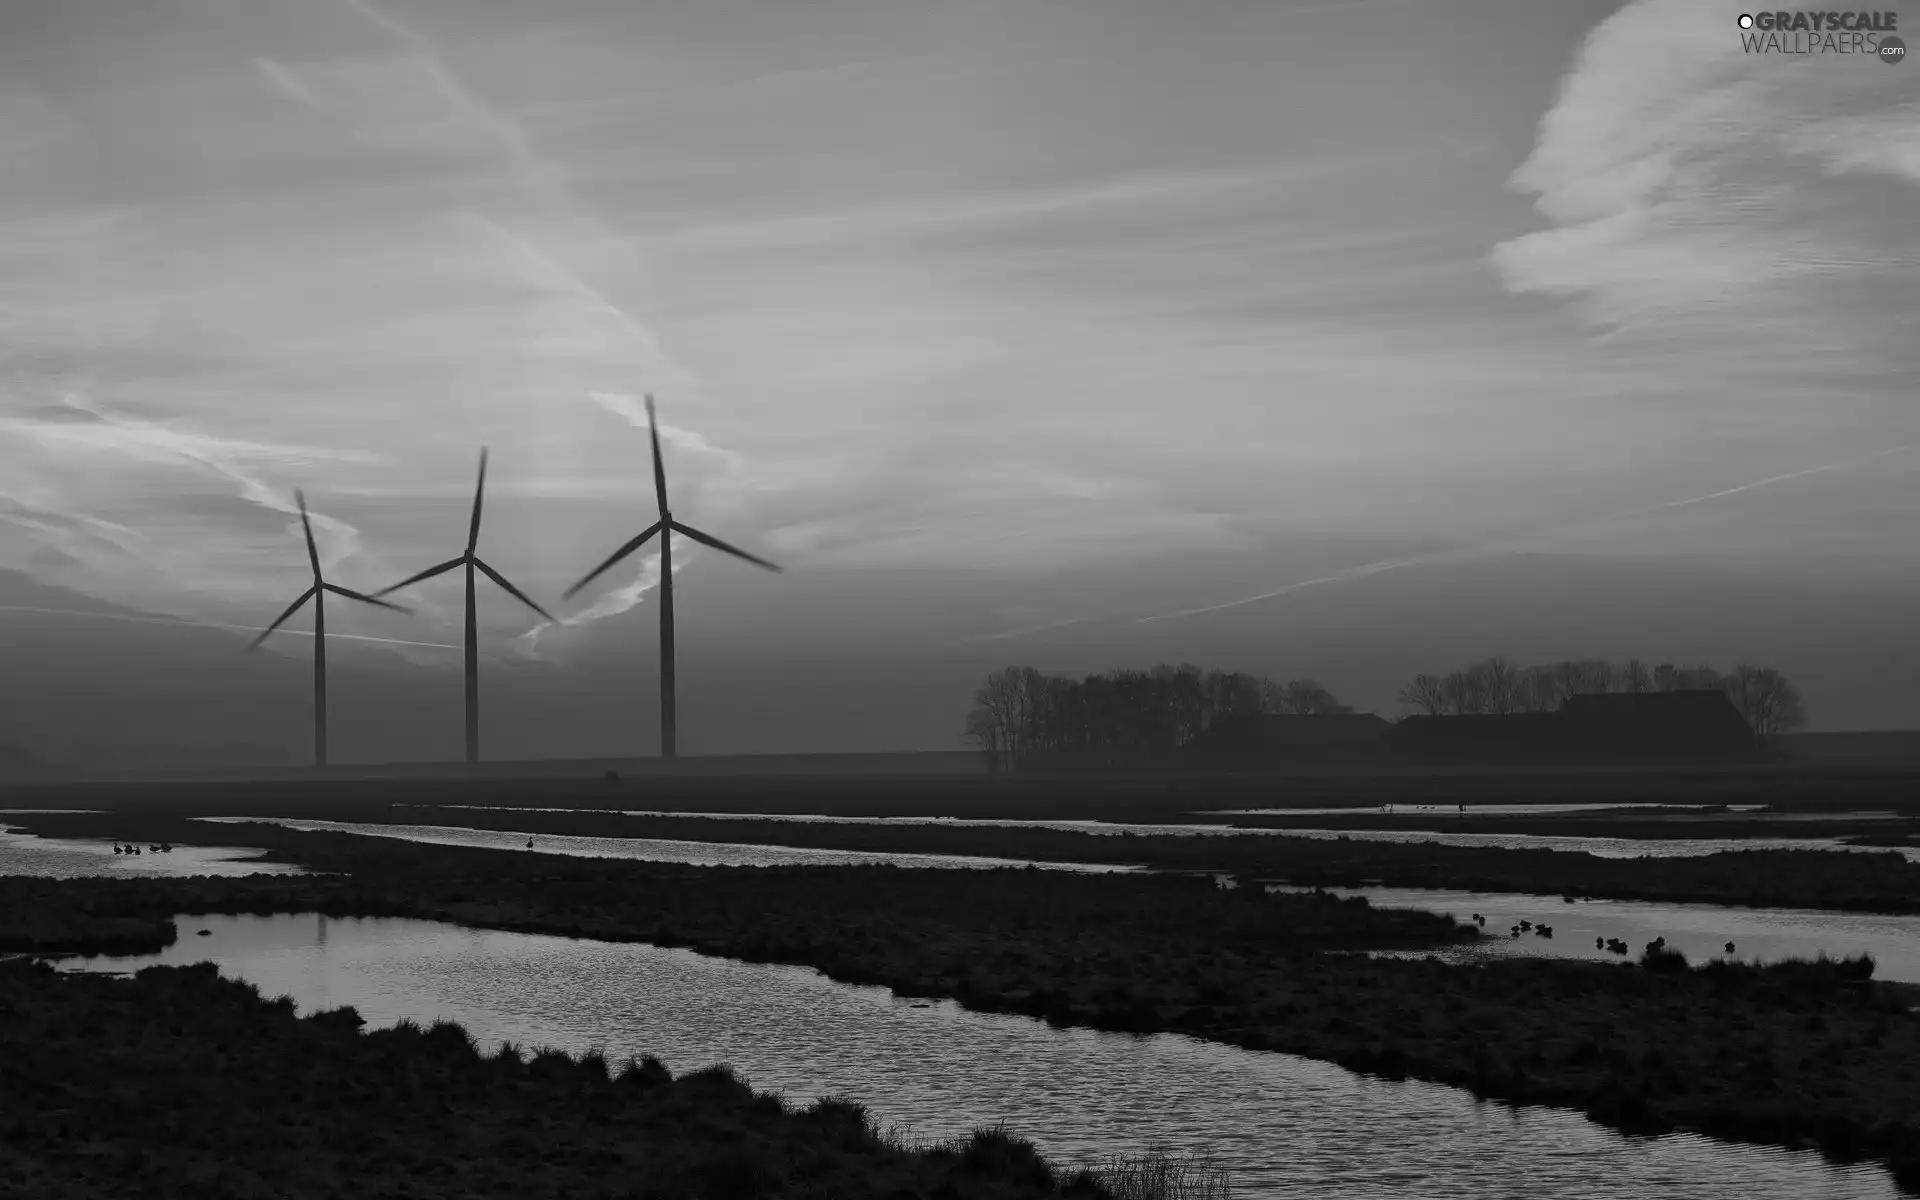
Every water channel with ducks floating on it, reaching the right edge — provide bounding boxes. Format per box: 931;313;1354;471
1267;883;1920;983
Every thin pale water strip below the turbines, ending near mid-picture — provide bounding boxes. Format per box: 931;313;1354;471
194;816;1140;874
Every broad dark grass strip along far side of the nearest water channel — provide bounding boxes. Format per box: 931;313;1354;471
0;828;1920;1194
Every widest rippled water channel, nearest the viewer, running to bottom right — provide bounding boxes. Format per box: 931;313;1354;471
63;914;1899;1200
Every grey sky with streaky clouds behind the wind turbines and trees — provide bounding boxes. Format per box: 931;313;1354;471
0;0;1920;756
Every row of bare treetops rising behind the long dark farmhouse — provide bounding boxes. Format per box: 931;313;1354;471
1400;657;1807;737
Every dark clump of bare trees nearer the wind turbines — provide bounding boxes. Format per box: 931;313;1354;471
966;662;1352;770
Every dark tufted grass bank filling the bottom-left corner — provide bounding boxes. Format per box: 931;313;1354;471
0;964;1136;1200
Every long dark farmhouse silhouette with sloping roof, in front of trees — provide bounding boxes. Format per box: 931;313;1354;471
1386;689;1759;766
